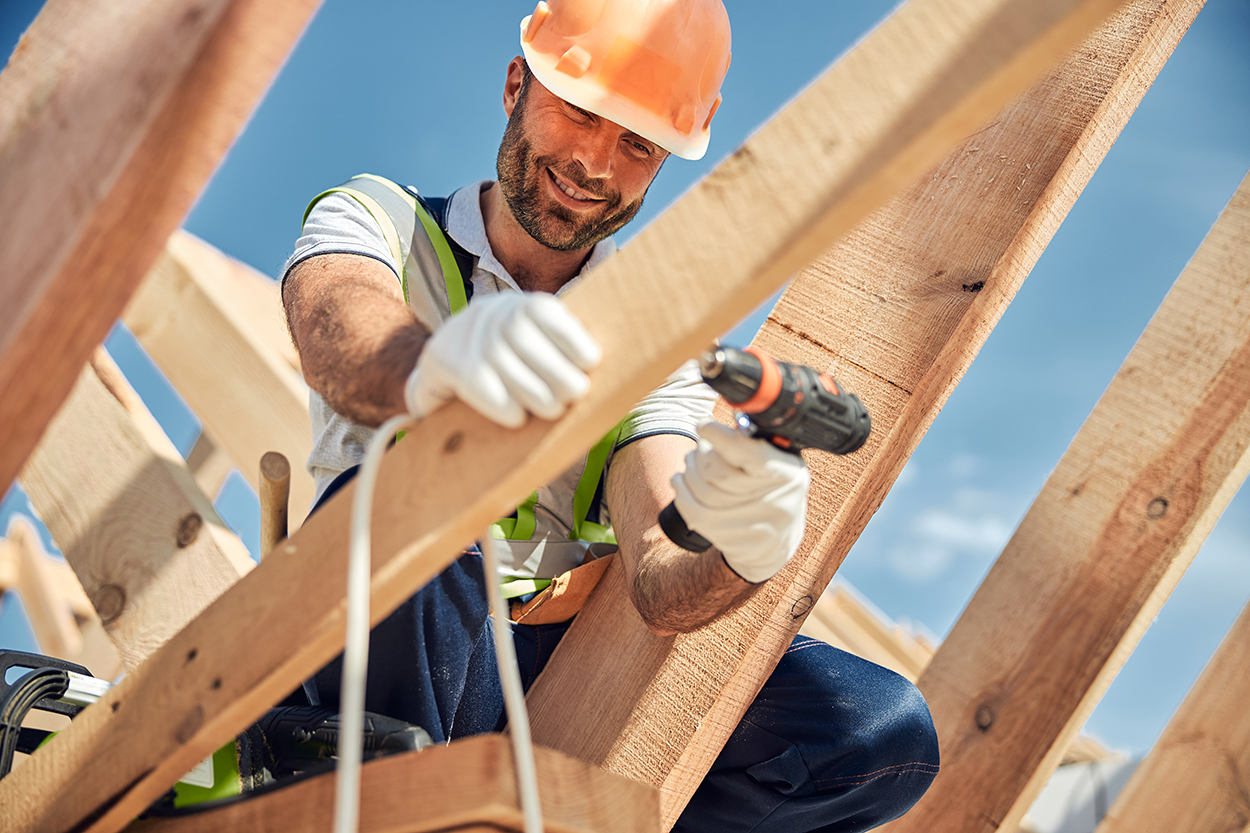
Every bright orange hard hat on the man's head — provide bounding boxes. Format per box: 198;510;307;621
521;0;729;159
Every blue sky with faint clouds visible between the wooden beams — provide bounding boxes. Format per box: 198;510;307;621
0;0;1250;753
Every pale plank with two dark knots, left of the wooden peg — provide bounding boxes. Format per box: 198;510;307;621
21;348;253;669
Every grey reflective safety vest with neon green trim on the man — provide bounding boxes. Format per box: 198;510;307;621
304;174;623;598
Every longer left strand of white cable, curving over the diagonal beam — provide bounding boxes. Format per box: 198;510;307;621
334;415;413;833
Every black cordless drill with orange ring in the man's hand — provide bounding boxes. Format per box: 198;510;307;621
660;348;873;553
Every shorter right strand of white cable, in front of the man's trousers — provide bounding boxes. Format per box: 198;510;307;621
480;529;543;833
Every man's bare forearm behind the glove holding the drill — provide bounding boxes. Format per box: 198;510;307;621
606;434;759;635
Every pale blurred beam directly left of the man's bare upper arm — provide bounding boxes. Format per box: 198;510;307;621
123;231;314;523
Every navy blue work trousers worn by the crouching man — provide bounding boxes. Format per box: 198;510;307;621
310;470;938;833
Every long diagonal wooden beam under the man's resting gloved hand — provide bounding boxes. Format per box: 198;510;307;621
0;0;1135;832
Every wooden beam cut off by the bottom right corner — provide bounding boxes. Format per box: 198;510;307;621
1098;592;1250;833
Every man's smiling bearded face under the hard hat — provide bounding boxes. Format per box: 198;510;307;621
496;69;668;251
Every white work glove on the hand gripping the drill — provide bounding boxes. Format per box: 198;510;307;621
673;423;810;584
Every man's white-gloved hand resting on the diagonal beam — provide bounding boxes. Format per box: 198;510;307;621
404;291;603;428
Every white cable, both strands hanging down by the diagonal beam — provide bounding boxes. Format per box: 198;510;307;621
334;415;543;833
